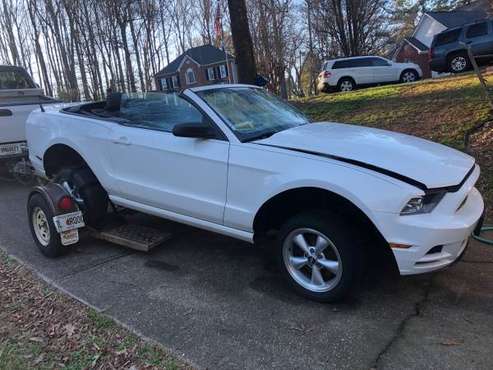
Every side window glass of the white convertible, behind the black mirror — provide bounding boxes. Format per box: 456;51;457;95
117;93;206;132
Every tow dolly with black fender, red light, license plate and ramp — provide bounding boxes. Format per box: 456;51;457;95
27;182;171;258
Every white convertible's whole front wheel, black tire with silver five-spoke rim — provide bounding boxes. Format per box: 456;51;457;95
278;212;361;302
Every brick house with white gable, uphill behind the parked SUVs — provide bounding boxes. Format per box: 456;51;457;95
393;0;492;78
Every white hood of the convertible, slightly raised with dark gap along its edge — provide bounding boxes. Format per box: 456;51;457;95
255;122;475;189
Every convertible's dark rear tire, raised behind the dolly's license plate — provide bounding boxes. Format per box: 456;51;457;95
55;167;109;229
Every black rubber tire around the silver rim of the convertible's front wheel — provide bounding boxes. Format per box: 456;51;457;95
277;211;363;302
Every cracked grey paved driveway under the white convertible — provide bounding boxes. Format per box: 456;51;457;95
0;178;493;369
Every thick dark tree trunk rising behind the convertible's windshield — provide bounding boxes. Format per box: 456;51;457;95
228;0;257;84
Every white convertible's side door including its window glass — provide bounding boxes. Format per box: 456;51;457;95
110;94;229;224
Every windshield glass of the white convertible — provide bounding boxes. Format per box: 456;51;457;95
197;87;309;142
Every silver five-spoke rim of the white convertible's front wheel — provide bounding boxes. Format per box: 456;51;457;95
283;228;342;292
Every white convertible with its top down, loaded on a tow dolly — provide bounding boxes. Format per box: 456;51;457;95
27;85;484;301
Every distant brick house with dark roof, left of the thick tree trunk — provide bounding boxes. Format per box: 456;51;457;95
154;45;237;92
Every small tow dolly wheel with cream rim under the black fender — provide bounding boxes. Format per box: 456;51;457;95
27;194;66;258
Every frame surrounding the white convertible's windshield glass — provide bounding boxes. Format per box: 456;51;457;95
189;84;312;143
